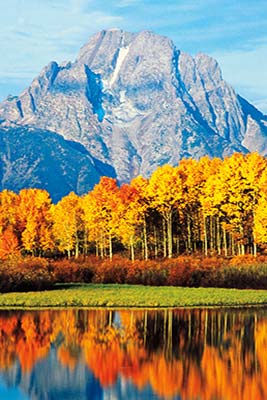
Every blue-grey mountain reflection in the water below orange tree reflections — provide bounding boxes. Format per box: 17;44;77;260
1;348;161;400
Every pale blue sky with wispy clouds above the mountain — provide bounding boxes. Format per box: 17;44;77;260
0;0;267;113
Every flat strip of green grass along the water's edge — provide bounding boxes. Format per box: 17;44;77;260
0;284;267;308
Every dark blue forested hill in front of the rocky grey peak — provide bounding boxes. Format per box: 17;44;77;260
0;126;115;202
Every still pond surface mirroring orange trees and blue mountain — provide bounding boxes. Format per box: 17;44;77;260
0;309;267;400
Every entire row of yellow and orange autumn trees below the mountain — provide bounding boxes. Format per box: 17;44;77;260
0;153;267;260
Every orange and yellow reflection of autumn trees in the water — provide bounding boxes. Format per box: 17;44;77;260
0;309;267;400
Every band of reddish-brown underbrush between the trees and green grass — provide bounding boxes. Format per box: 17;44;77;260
0;255;267;292
